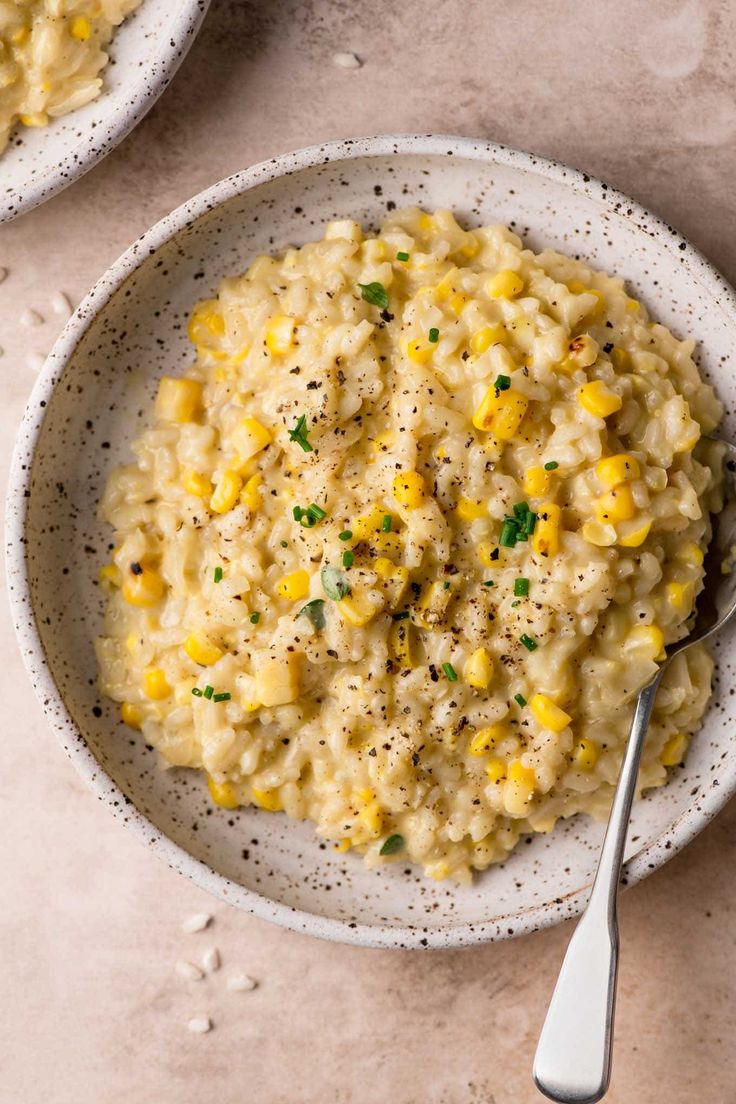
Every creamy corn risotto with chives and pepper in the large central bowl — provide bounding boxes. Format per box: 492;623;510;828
97;209;722;880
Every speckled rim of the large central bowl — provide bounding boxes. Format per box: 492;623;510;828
6;134;736;948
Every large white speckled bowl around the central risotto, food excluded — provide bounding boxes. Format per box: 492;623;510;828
7;137;736;947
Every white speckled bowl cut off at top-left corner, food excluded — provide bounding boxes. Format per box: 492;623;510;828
0;0;210;222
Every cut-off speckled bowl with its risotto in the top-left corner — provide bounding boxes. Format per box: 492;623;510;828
0;0;210;222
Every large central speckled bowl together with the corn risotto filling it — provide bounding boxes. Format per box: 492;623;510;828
8;137;736;946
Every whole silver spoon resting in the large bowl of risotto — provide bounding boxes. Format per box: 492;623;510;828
534;442;736;1104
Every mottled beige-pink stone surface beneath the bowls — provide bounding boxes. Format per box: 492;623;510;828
0;0;736;1104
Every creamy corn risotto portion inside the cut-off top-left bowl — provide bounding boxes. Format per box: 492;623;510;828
0;0;141;153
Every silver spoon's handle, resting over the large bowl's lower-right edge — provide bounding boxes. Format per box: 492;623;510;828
534;668;662;1104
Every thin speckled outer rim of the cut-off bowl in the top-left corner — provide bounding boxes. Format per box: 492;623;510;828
0;0;211;224
